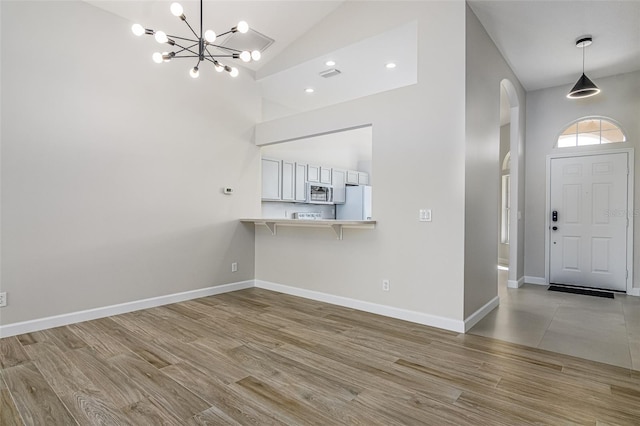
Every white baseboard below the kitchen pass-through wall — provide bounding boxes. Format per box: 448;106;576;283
256;280;465;333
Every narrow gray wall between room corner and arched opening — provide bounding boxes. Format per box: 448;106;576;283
464;6;525;318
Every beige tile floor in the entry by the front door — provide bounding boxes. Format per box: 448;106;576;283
469;270;640;370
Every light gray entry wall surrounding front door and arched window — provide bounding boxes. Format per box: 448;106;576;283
525;72;640;287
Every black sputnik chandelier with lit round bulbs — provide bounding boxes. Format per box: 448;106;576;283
131;0;261;78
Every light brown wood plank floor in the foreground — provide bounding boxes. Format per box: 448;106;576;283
0;289;640;426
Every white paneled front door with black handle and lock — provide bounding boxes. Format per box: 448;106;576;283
549;153;629;291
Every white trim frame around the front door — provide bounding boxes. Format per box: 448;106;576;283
544;150;640;295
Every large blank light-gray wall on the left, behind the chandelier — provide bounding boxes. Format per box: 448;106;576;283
1;1;260;325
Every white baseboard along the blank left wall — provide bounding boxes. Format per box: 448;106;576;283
0;280;254;338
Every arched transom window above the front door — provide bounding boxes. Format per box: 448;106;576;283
556;117;627;148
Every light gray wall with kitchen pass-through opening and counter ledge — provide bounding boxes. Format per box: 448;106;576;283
256;1;468;322
